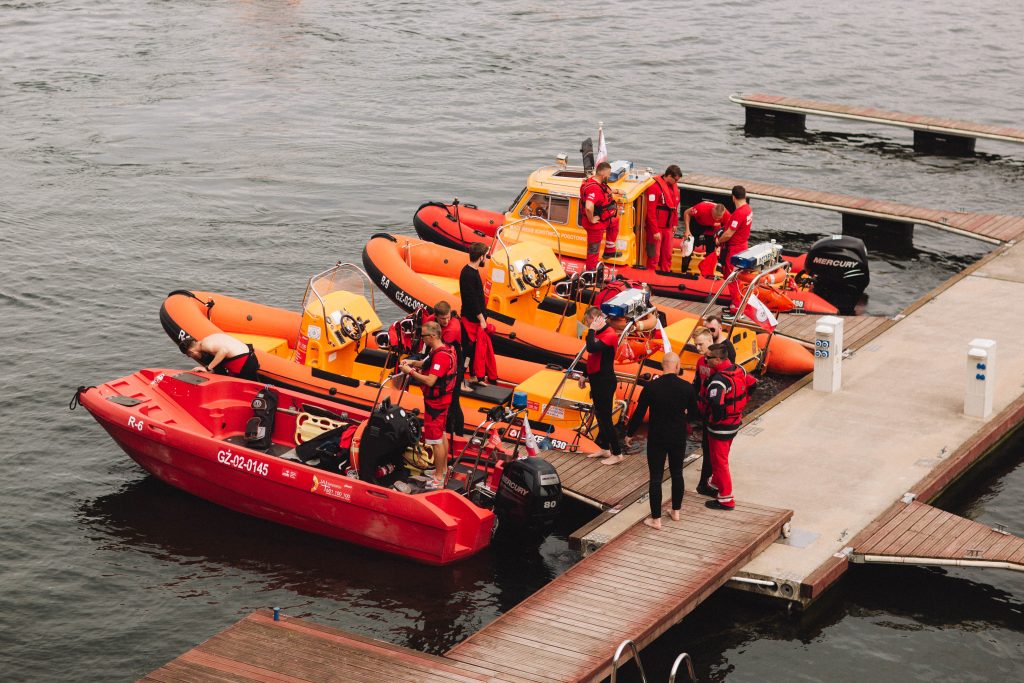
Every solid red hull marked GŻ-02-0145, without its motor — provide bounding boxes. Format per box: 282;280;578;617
79;370;494;564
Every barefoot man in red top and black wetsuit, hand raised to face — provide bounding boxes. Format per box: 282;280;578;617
584;306;625;465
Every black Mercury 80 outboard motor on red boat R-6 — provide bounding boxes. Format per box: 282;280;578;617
495;458;562;533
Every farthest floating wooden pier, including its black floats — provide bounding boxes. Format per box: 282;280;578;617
729;93;1024;156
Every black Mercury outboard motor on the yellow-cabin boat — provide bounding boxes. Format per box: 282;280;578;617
804;234;870;313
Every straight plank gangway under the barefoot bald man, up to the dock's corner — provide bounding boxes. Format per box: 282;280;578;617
444;495;792;683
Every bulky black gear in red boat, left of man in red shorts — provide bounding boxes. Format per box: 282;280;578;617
359;400;422;486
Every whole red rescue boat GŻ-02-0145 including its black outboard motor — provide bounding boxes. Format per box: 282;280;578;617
72;370;561;564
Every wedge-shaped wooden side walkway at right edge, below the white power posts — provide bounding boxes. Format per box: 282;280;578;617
850;501;1024;571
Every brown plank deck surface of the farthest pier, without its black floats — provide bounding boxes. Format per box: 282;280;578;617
729;93;1024;142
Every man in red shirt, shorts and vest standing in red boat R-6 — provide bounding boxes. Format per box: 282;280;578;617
398;322;459;488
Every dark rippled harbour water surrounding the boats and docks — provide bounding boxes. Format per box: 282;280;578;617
0;0;1024;681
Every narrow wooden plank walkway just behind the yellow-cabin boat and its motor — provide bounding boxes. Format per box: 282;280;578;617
679;173;1024;244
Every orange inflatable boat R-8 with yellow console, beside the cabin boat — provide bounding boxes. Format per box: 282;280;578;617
362;233;814;374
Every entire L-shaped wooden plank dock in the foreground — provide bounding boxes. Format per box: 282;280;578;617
142;496;792;683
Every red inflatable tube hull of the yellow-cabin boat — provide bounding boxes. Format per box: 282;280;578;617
413;197;839;315
